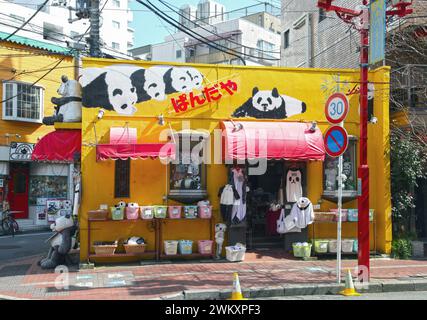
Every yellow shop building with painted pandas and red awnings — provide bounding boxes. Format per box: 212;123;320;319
80;58;391;261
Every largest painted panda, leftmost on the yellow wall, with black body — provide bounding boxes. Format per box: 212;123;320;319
79;68;138;115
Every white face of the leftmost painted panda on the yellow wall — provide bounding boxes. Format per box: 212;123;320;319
105;72;138;115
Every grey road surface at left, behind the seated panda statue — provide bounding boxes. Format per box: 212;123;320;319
0;232;52;263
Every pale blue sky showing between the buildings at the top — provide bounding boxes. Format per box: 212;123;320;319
131;0;278;48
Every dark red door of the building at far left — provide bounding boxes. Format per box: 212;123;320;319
8;162;30;219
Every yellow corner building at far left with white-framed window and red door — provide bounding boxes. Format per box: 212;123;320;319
0;32;74;226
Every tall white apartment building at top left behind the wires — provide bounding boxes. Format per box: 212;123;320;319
0;0;134;58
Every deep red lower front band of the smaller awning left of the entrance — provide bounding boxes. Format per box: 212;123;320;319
96;143;176;161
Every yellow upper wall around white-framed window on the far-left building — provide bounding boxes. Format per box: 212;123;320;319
0;42;74;145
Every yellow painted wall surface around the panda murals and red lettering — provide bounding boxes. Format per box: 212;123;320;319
80;59;391;261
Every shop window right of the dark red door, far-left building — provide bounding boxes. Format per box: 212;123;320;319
28;176;68;205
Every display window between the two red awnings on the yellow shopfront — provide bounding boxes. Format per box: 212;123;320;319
169;132;208;202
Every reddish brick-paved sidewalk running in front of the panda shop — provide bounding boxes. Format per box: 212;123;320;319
0;252;427;300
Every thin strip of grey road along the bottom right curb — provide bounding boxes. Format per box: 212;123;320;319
269;291;427;300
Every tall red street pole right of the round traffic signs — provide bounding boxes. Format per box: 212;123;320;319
317;0;412;281
